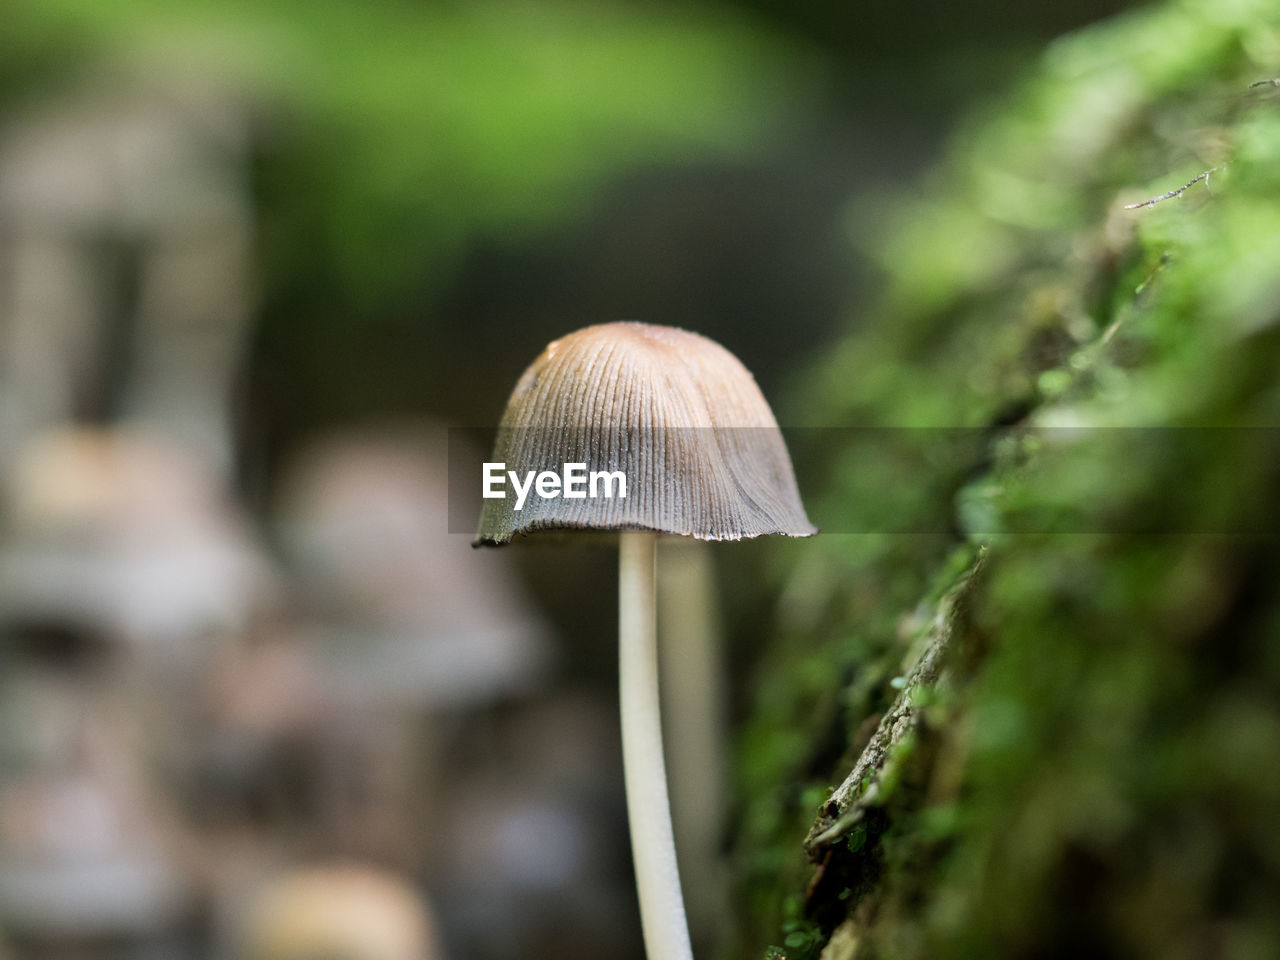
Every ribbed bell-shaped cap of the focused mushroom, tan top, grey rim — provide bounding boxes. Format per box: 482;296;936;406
476;323;818;545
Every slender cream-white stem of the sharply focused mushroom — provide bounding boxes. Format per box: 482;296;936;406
618;531;694;960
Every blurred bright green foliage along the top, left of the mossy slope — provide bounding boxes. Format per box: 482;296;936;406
0;0;804;307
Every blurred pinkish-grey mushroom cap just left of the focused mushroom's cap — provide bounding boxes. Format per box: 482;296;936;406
278;424;548;712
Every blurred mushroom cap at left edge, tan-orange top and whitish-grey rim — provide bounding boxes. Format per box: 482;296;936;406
0;428;275;675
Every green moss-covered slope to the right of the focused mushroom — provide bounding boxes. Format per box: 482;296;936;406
737;0;1280;960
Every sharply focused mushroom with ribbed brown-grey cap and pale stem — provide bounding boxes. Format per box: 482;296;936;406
476;323;817;960
